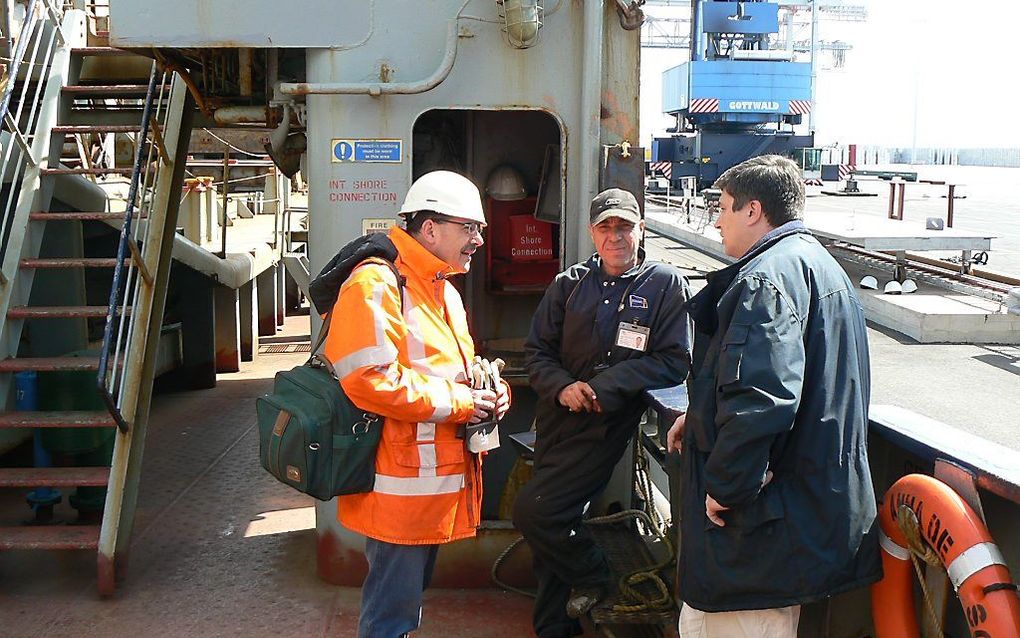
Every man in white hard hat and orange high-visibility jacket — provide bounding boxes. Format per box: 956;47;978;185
325;170;510;638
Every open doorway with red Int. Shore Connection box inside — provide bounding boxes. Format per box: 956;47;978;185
412;108;565;521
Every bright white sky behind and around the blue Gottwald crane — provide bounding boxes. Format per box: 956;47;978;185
641;0;1020;148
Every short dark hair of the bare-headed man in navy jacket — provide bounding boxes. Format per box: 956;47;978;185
714;155;804;228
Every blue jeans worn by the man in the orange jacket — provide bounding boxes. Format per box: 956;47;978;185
358;538;439;638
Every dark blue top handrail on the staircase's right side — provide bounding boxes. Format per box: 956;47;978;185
96;64;162;433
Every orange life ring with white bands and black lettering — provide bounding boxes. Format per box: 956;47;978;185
871;474;1020;638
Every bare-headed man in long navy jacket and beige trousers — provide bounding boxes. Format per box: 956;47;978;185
667;155;881;638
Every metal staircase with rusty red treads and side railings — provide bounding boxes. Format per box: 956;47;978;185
0;0;194;595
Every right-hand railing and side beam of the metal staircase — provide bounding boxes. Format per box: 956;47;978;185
98;69;194;594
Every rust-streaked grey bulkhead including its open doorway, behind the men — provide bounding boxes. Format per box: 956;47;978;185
297;2;642;586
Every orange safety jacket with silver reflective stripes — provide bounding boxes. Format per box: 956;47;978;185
325;228;481;545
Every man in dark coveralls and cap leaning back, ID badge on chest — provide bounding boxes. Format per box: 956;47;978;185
513;189;690;638
